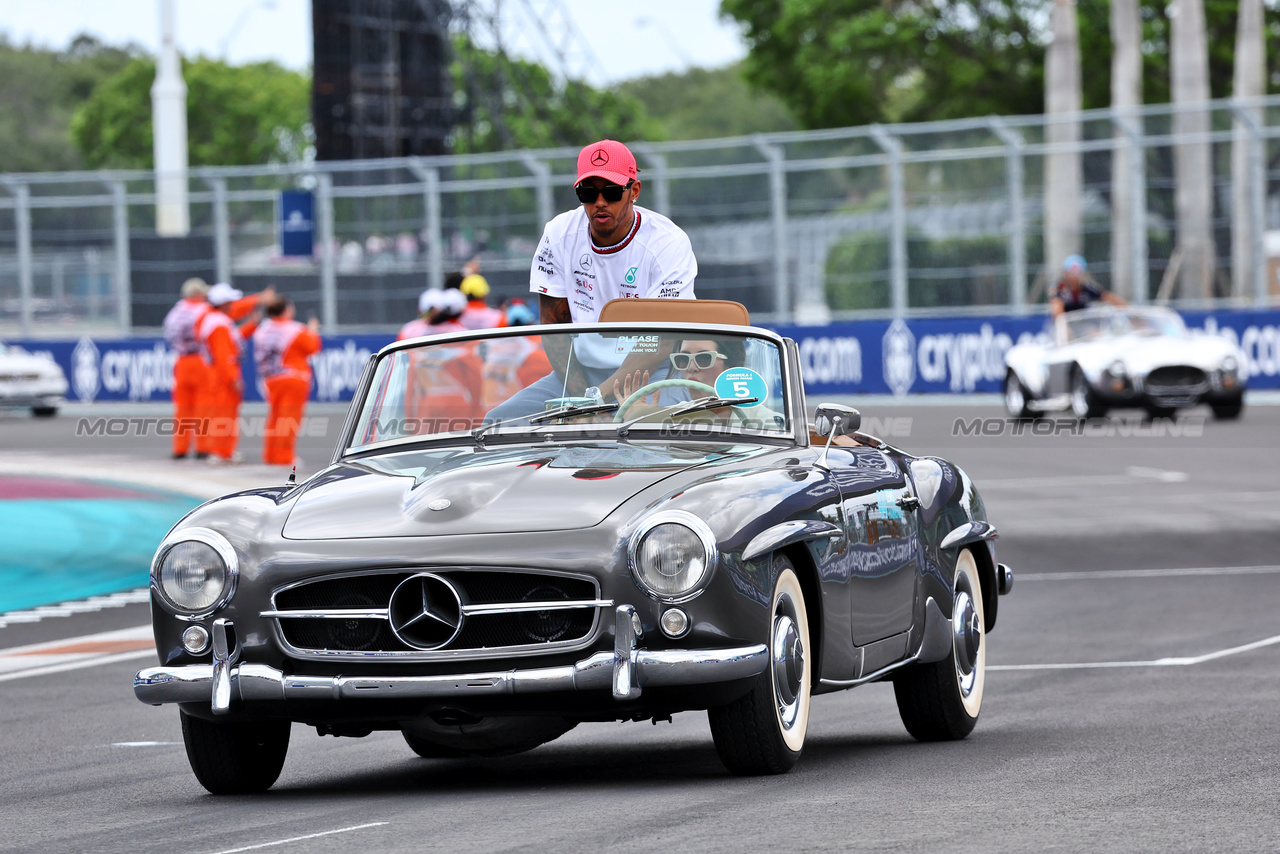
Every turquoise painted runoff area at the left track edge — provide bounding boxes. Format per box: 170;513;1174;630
0;493;200;613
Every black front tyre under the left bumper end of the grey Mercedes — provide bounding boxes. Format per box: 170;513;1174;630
180;712;291;795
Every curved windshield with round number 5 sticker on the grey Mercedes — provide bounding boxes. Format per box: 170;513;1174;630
347;329;791;451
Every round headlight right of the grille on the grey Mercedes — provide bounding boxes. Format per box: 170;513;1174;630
631;511;717;602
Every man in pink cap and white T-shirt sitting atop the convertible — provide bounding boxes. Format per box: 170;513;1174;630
485;140;698;421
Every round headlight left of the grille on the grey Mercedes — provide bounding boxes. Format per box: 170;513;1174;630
151;528;237;616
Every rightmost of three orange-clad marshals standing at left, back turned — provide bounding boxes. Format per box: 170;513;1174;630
253;296;321;466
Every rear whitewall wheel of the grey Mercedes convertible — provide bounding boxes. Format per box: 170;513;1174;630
893;549;987;741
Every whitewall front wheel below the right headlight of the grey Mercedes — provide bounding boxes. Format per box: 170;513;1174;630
707;557;812;775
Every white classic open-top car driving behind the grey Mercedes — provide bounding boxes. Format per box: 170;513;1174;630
1005;306;1247;419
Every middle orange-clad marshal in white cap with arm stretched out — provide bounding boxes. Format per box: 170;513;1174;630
196;282;263;465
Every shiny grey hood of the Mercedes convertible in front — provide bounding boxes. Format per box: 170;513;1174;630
283;443;762;539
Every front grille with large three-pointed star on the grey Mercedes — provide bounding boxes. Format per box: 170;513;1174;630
262;567;612;659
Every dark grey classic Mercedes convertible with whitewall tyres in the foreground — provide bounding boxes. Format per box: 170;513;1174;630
134;300;1012;793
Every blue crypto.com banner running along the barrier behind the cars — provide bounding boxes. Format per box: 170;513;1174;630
10;310;1280;403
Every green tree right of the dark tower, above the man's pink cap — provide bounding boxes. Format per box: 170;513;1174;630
452;37;660;154
